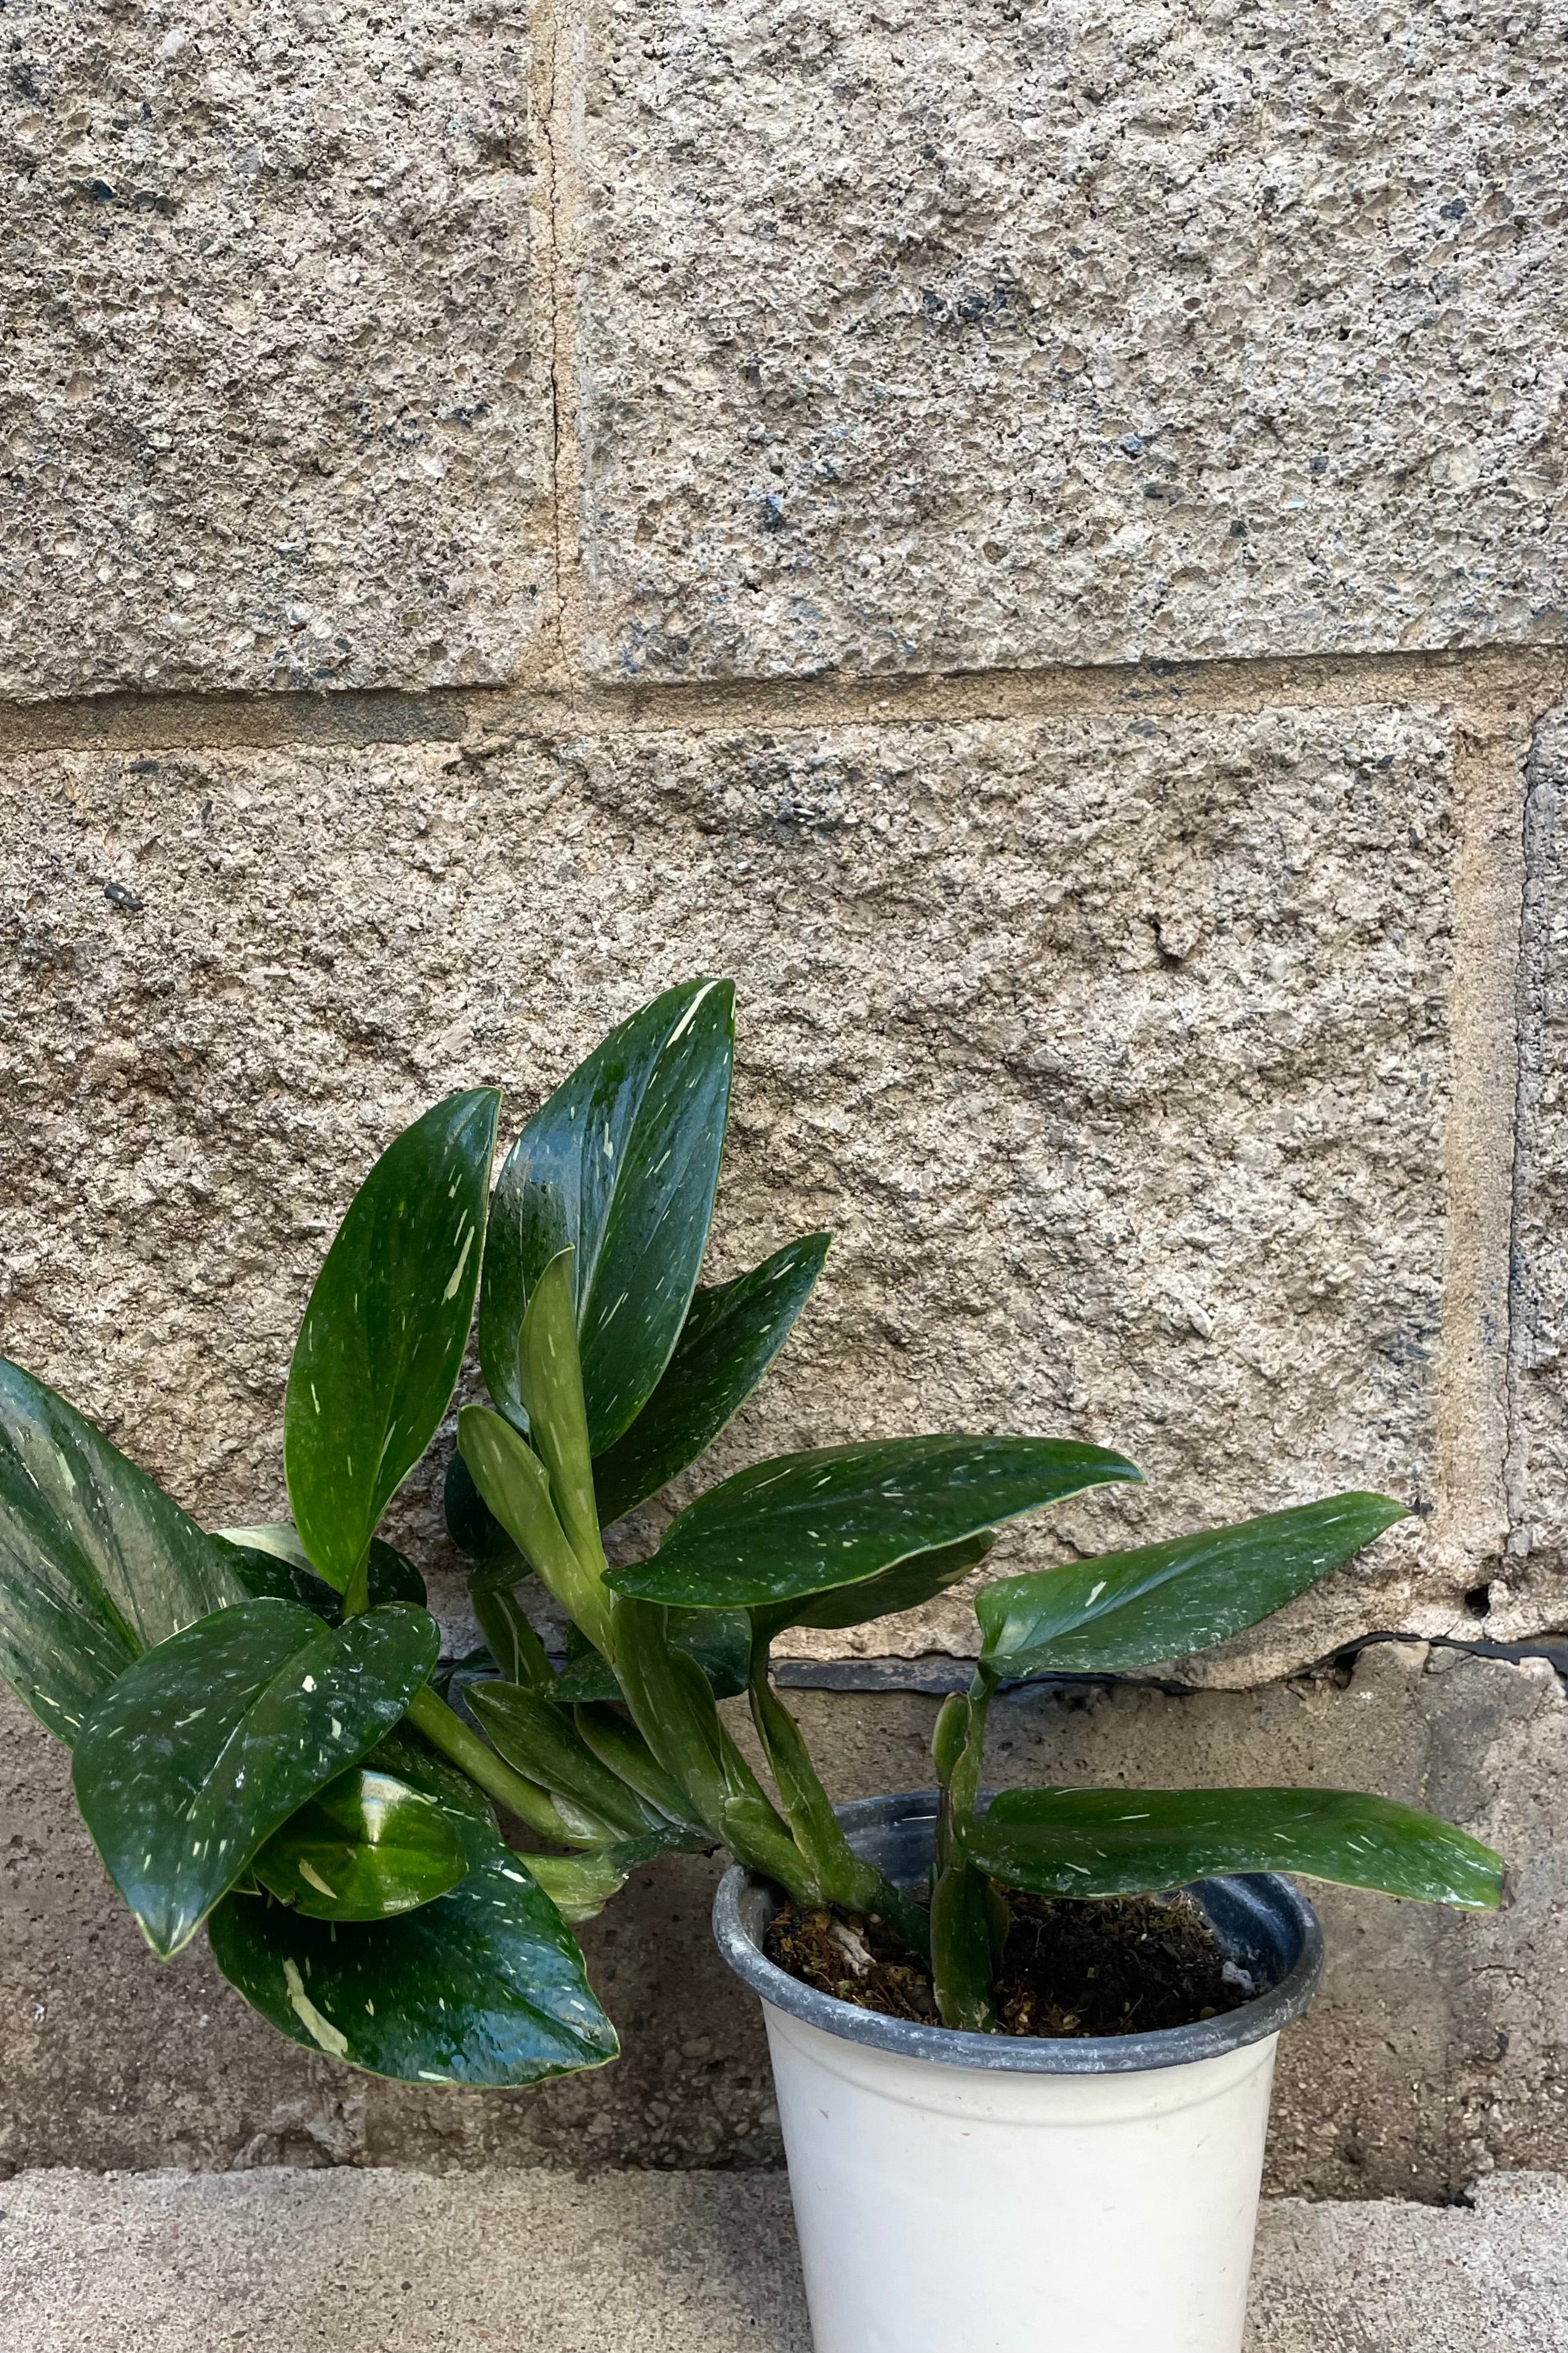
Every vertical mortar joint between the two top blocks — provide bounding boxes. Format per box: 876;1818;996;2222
533;0;585;711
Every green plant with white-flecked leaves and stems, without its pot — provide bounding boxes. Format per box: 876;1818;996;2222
0;981;1500;2085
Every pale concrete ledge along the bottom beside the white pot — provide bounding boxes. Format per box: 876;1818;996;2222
0;2167;1568;2353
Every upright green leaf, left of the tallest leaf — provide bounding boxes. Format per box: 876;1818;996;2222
284;1087;501;1593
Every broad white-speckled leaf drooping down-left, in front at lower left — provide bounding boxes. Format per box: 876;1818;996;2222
71;1600;440;1960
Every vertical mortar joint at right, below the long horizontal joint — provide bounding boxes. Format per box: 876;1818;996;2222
1434;690;1533;1591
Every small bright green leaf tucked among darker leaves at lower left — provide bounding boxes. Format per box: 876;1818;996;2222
252;1765;468;1920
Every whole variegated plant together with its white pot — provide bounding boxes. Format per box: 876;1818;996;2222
0;981;1502;2353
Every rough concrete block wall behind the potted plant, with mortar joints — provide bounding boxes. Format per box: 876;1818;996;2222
0;0;1568;2198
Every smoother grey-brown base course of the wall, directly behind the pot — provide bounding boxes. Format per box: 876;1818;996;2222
0;1645;1568;2202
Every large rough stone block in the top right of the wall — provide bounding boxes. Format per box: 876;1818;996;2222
574;0;1566;677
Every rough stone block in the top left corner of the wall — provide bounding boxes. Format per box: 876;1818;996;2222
0;0;553;696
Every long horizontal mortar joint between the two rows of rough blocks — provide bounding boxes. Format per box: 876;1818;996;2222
0;645;1568;758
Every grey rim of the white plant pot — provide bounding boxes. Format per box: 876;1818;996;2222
712;1788;1324;2075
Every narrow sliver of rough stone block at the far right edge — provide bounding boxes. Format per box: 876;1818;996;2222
1500;713;1568;1628
